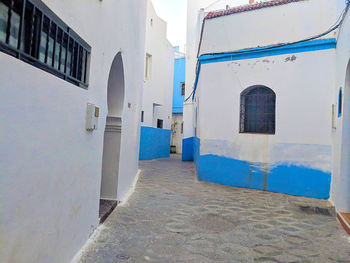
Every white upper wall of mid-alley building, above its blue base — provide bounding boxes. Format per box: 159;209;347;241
142;1;174;130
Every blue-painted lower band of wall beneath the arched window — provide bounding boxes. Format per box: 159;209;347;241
197;155;331;199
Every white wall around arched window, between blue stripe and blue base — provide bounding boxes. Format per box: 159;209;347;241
197;50;335;172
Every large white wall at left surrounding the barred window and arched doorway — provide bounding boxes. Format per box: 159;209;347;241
0;0;146;263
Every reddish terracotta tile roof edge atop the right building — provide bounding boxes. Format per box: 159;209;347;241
206;0;305;19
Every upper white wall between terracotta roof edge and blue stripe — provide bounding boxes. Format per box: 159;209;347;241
200;0;338;54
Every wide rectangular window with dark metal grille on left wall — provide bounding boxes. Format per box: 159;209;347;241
0;0;91;88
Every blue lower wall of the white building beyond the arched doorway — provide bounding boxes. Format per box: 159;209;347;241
139;127;171;160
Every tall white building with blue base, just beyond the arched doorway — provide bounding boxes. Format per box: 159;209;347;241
140;0;174;160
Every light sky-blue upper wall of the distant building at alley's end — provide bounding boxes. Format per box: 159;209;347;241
173;58;186;113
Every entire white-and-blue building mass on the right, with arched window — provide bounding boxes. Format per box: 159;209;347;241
183;0;350;227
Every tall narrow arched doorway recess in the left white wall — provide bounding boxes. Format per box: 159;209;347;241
100;52;125;221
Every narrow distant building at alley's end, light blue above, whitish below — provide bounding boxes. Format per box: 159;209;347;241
171;47;186;154
